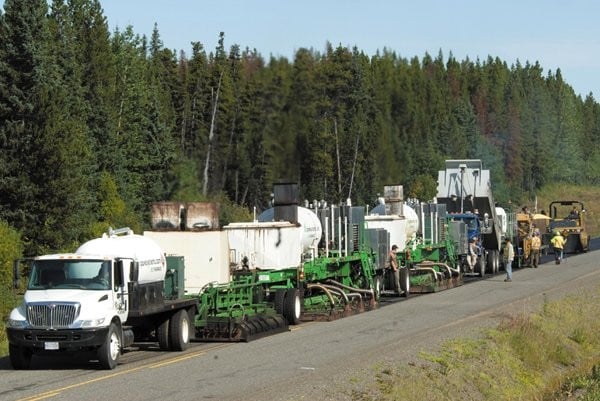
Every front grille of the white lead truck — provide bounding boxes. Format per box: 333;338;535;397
27;302;80;329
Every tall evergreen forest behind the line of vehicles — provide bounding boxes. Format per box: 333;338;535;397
0;0;600;254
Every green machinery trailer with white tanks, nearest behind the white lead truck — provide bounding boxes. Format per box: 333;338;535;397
186;184;379;341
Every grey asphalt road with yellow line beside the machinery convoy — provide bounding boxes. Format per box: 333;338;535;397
0;239;600;401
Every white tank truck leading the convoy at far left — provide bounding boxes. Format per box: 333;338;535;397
6;228;198;369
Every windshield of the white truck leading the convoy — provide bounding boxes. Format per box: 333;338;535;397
27;259;112;290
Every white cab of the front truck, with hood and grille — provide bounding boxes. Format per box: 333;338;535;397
7;254;132;368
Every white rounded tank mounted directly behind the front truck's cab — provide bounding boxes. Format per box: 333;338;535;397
76;232;166;282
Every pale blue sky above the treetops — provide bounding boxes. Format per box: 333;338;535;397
100;0;600;100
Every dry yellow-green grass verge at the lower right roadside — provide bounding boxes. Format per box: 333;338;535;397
352;288;600;401
